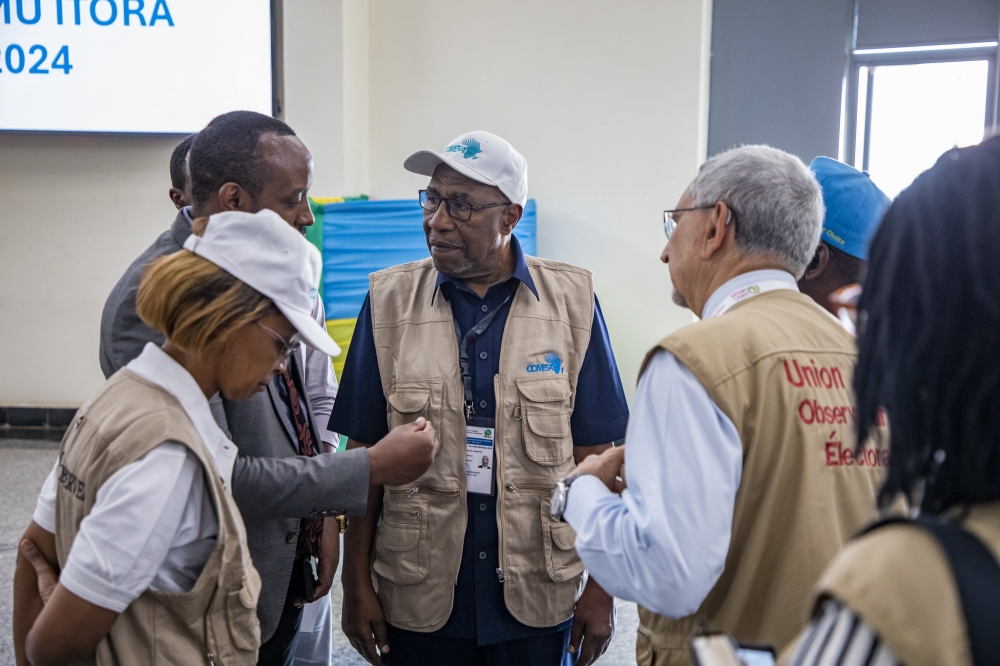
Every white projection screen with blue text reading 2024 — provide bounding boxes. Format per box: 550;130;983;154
0;0;271;133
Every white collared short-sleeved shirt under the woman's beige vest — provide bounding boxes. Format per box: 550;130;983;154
34;343;237;613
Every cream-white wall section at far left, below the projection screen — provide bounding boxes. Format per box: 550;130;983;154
0;135;179;407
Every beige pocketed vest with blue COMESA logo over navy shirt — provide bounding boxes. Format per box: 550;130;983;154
370;257;594;632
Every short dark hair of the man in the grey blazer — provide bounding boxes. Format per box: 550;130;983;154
188;111;295;206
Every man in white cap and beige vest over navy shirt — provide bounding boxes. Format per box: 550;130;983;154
340;131;628;666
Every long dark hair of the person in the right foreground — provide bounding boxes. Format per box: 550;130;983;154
854;138;1000;513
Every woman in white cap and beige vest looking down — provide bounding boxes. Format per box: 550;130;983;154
14;210;436;666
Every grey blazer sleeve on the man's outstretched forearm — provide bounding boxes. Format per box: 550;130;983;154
233;448;369;519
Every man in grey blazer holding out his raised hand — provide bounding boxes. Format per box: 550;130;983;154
100;111;440;664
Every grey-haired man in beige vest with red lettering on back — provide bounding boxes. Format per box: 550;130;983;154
552;146;888;666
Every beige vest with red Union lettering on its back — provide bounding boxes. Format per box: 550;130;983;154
636;289;888;666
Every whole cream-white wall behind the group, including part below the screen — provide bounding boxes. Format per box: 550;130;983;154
0;0;711;407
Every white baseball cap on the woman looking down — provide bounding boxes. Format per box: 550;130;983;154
184;209;340;356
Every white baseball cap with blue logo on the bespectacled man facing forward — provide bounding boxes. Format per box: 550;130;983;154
403;130;528;206
